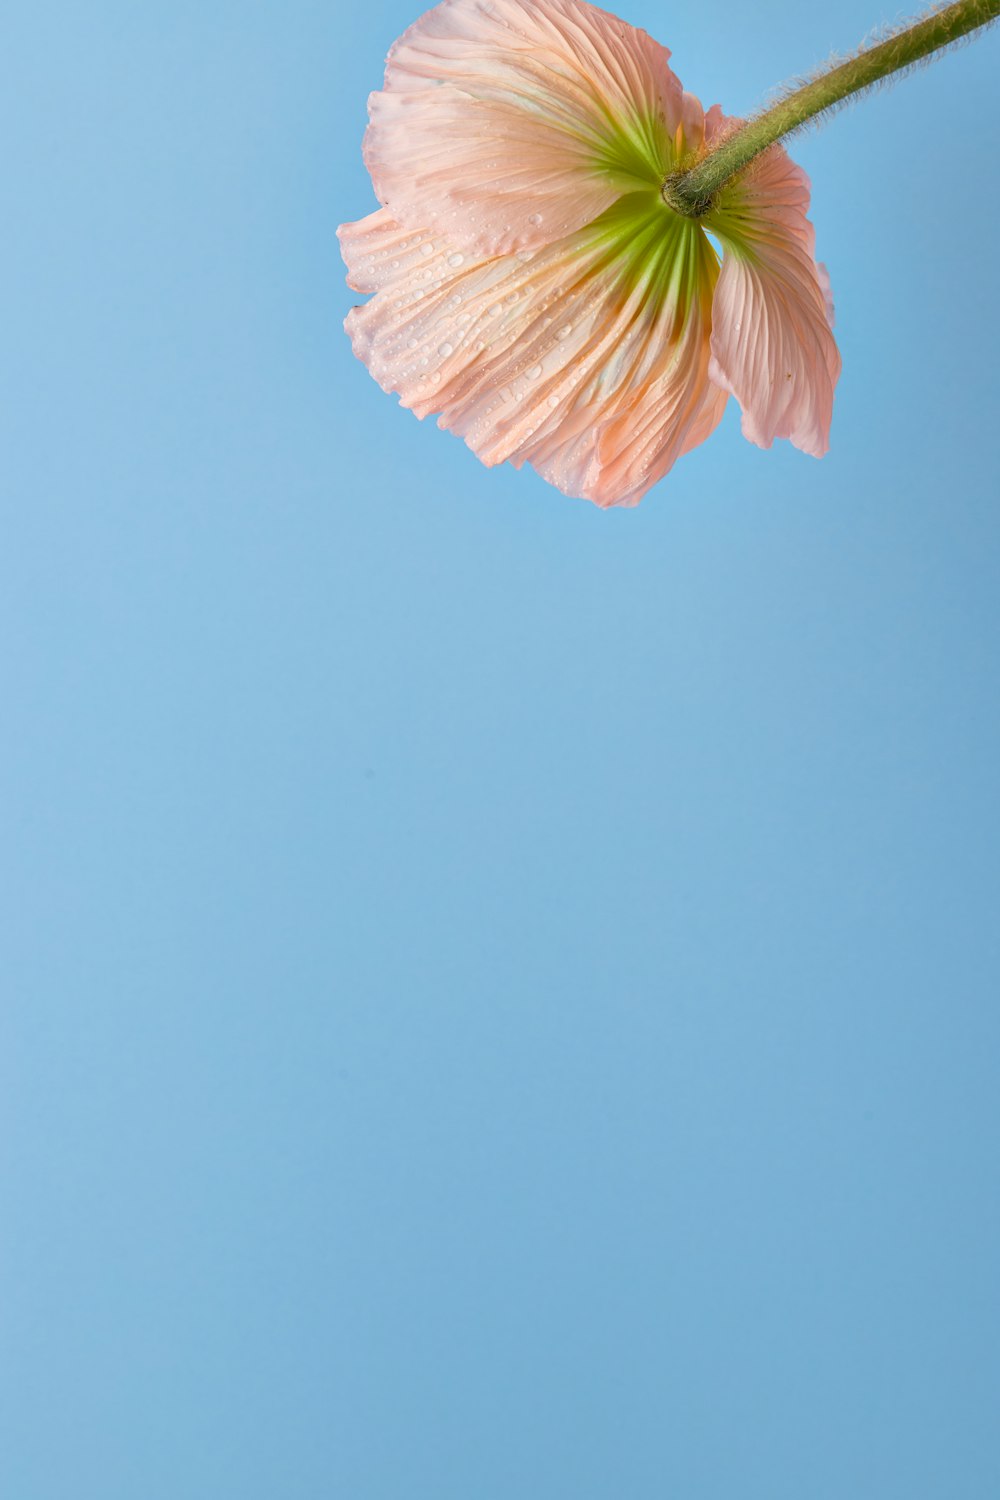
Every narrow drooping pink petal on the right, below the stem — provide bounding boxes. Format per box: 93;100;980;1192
705;135;841;458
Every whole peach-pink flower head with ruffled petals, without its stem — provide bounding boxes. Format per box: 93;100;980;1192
339;0;840;506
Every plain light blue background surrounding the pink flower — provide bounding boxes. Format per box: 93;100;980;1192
0;0;1000;1500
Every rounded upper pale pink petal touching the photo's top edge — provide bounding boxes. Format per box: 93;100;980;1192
364;0;703;257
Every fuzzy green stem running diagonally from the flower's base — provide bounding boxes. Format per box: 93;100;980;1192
663;0;1000;218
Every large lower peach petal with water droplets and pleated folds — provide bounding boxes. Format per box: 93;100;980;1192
340;195;726;506
